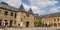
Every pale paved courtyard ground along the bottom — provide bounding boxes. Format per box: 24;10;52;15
0;27;60;30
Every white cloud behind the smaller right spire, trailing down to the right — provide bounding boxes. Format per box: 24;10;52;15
23;4;45;15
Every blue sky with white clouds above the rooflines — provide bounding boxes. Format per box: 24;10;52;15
0;0;60;15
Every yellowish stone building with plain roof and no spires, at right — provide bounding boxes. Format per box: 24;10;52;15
42;12;60;27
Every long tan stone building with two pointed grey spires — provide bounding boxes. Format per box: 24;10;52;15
0;2;34;28
